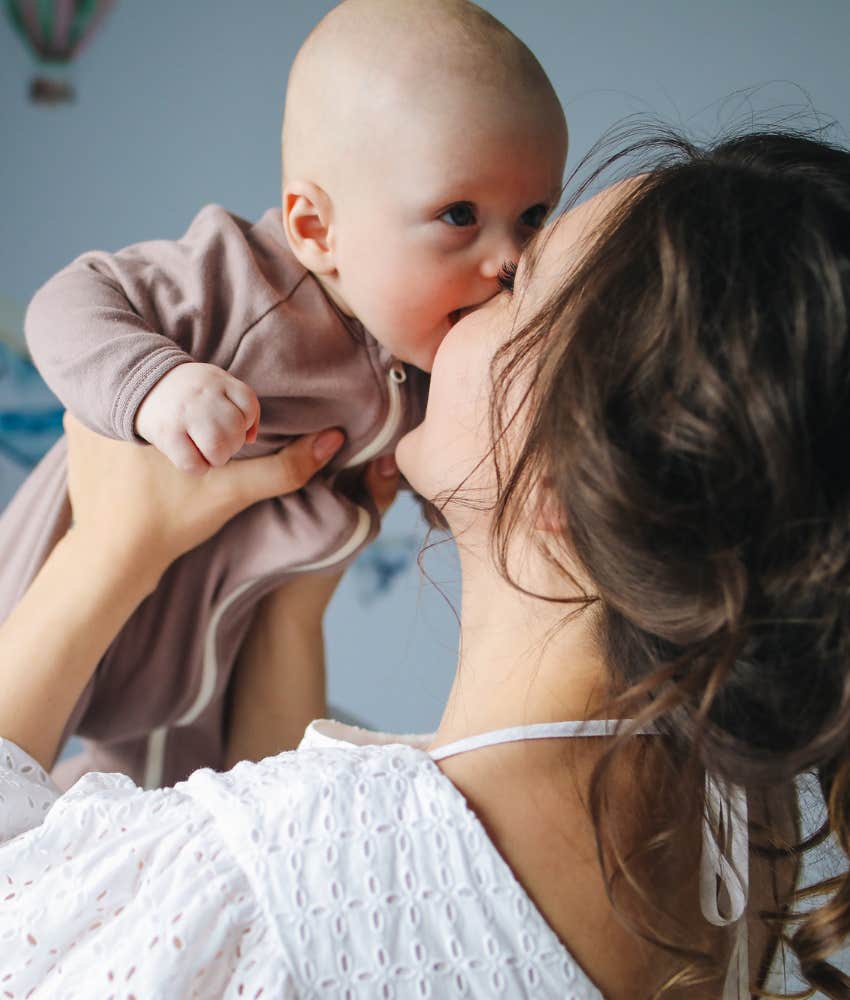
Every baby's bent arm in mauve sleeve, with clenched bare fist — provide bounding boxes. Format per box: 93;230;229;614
26;206;268;467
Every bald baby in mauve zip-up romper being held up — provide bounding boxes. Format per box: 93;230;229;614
0;0;567;787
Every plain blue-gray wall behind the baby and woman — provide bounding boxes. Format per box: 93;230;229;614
0;0;850;984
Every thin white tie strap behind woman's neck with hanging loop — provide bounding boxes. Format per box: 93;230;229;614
428;719;750;1000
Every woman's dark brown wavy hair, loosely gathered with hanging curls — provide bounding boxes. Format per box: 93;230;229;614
486;130;850;1000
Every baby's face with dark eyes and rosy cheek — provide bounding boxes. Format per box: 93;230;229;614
334;104;566;371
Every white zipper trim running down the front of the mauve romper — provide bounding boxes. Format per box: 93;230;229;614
143;361;407;788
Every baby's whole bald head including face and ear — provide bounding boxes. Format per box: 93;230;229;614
282;0;567;371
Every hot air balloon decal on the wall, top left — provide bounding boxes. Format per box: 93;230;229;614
5;0;114;104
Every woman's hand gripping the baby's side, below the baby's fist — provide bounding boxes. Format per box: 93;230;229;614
64;413;344;586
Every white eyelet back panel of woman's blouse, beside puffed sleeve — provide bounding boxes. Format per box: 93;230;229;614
188;723;600;1000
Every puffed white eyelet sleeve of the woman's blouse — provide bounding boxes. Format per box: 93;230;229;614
0;740;293;1000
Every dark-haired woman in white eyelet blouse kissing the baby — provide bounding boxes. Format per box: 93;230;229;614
0;129;850;998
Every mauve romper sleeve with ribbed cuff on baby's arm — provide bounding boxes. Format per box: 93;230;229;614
24;205;284;440
